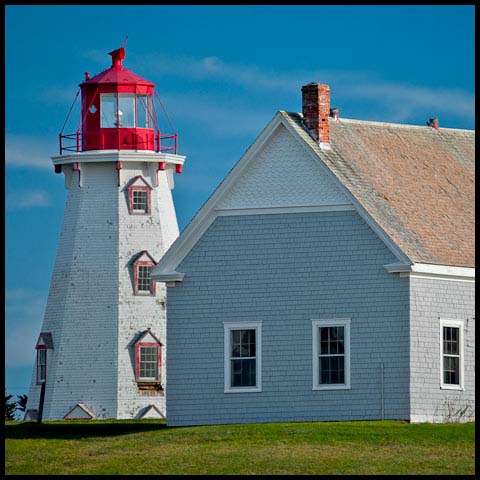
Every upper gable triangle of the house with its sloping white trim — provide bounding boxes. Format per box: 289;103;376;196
151;111;411;286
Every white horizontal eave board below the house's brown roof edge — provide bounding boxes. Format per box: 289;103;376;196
384;263;475;282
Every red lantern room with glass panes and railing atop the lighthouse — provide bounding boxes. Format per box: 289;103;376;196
60;47;177;155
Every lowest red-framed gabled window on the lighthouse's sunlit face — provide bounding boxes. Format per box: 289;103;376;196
135;328;162;388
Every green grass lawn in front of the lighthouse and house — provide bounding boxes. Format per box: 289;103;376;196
5;420;475;475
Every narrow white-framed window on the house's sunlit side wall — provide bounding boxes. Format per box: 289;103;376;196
440;318;464;390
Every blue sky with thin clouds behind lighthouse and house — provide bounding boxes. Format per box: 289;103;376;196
5;5;475;400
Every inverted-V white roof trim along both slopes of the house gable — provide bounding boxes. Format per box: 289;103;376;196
150;111;410;282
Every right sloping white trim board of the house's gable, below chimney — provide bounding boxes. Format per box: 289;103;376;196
278;113;411;263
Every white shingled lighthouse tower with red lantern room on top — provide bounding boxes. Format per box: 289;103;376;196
26;48;185;420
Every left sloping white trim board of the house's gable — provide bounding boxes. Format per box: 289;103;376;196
150;112;286;280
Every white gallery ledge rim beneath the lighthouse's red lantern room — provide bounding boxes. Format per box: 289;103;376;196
51;150;187;165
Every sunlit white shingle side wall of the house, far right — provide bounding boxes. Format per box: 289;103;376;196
410;277;475;422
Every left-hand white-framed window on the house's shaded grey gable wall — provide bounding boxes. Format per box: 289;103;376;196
223;322;262;393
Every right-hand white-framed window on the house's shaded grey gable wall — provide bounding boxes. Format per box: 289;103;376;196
312;318;350;390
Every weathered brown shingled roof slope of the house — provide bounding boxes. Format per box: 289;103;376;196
280;112;475;267
